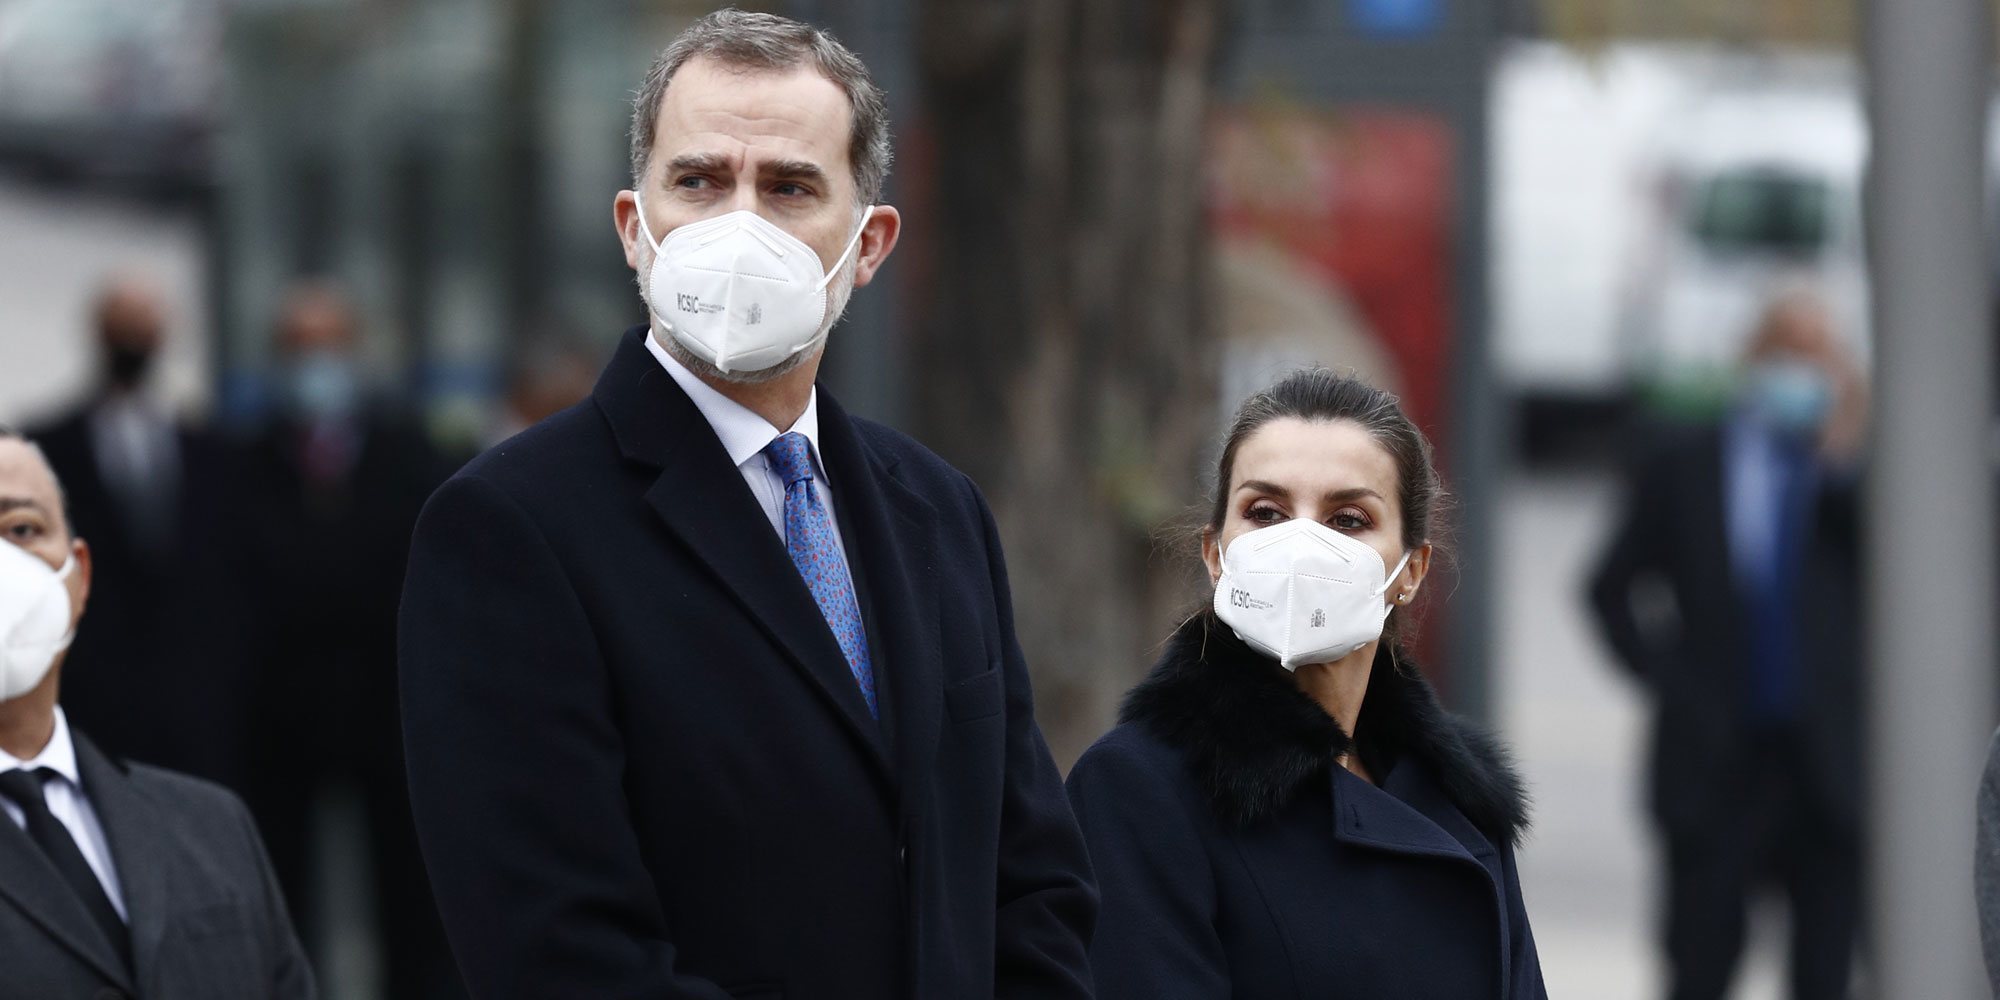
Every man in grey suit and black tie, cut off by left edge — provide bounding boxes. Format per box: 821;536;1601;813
0;426;314;1000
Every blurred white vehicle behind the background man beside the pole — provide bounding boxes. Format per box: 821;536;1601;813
1492;42;1868;456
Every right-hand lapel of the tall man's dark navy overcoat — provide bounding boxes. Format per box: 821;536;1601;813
820;390;944;814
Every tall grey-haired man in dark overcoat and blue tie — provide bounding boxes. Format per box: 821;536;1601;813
402;10;1096;1000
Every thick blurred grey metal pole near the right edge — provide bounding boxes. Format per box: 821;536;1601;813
1864;0;1996;998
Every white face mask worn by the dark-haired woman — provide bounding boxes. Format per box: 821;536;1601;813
1216;518;1410;670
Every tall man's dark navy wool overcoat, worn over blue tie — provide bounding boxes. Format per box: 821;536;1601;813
402;330;1096;1000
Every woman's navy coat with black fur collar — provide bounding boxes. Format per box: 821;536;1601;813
1068;614;1548;1000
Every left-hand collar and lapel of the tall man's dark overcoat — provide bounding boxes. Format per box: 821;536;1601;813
592;328;890;778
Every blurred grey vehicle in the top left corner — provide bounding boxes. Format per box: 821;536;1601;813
0;0;222;190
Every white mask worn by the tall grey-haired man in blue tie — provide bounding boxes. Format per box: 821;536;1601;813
632;190;874;374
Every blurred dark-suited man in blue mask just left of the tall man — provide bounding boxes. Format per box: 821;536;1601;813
230;282;456;1000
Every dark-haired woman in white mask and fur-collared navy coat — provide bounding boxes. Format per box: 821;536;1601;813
1068;370;1548;1000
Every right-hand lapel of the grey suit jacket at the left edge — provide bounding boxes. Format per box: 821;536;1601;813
72;730;176;988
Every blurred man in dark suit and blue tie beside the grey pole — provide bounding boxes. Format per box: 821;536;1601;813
1590;292;1866;1000
